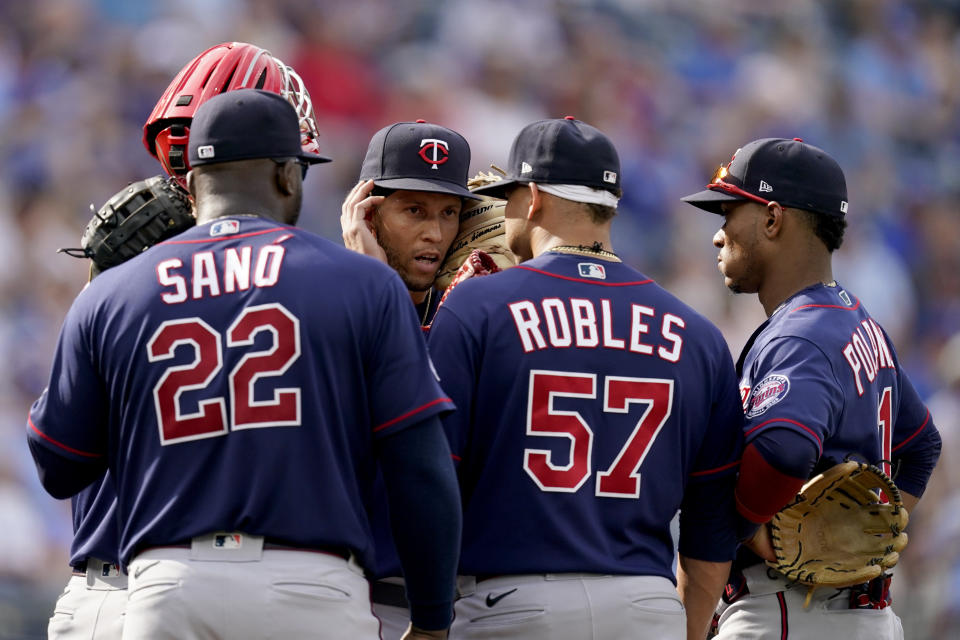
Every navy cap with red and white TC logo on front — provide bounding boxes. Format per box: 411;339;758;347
360;120;480;200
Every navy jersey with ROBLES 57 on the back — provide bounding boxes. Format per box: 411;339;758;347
428;252;743;579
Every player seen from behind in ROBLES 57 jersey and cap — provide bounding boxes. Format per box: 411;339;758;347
428;118;743;640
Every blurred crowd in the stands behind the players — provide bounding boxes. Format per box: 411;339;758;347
0;0;960;639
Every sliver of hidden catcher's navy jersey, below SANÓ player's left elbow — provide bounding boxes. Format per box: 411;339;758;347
70;473;120;566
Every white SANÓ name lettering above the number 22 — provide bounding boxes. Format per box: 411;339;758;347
157;244;285;304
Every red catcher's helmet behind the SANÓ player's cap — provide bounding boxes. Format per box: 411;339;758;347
143;42;319;188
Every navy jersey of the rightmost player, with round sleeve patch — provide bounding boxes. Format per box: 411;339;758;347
740;284;939;496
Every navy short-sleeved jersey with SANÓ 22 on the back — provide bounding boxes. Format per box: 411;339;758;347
30;216;452;566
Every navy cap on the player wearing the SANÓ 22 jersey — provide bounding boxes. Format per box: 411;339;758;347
188;89;330;167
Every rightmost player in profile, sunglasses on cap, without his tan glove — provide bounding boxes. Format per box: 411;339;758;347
683;138;940;639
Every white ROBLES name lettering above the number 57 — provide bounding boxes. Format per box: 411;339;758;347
508;298;686;362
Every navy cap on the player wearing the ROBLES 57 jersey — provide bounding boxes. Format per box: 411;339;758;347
476;116;620;198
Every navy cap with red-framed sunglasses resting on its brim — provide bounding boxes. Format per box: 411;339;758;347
681;138;847;217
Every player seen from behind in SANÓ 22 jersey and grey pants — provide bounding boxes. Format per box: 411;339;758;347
28;89;460;640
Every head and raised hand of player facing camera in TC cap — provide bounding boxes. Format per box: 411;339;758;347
340;120;479;326
